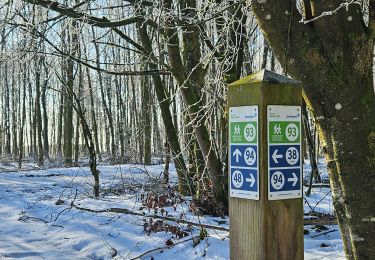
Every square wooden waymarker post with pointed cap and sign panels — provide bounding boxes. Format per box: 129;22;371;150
228;70;304;260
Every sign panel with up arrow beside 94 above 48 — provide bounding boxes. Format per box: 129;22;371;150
229;106;259;200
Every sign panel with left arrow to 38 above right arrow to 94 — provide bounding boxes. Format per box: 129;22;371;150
267;105;302;200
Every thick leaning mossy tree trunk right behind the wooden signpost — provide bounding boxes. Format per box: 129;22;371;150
252;0;375;259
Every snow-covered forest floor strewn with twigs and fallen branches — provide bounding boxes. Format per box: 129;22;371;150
0;159;344;260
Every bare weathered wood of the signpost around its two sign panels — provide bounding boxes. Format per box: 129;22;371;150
228;74;304;260
